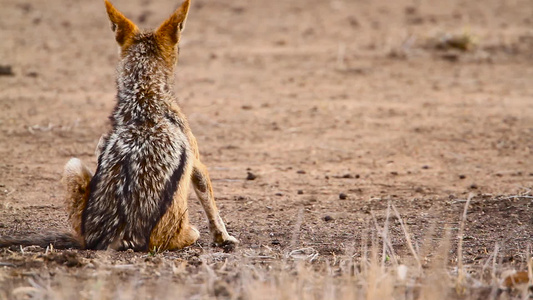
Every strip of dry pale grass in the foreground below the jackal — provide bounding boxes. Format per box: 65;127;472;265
0;197;533;300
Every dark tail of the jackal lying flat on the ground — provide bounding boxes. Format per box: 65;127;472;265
0;233;82;249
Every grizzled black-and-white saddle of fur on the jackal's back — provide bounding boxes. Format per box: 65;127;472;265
82;113;190;250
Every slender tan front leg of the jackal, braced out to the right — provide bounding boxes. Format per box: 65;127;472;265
192;159;239;245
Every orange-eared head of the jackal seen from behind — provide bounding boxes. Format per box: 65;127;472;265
104;0;190;67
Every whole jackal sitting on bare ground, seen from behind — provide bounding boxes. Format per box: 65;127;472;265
0;0;238;251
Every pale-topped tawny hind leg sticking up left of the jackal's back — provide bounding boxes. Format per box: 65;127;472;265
61;158;93;242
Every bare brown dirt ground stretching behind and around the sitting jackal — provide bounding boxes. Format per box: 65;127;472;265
0;0;533;298
